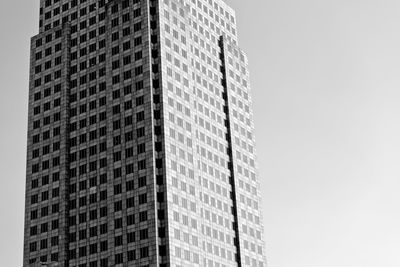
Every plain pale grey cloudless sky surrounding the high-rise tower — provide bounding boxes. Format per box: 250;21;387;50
0;0;400;267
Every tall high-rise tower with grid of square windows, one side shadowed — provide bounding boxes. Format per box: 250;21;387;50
24;0;266;267
